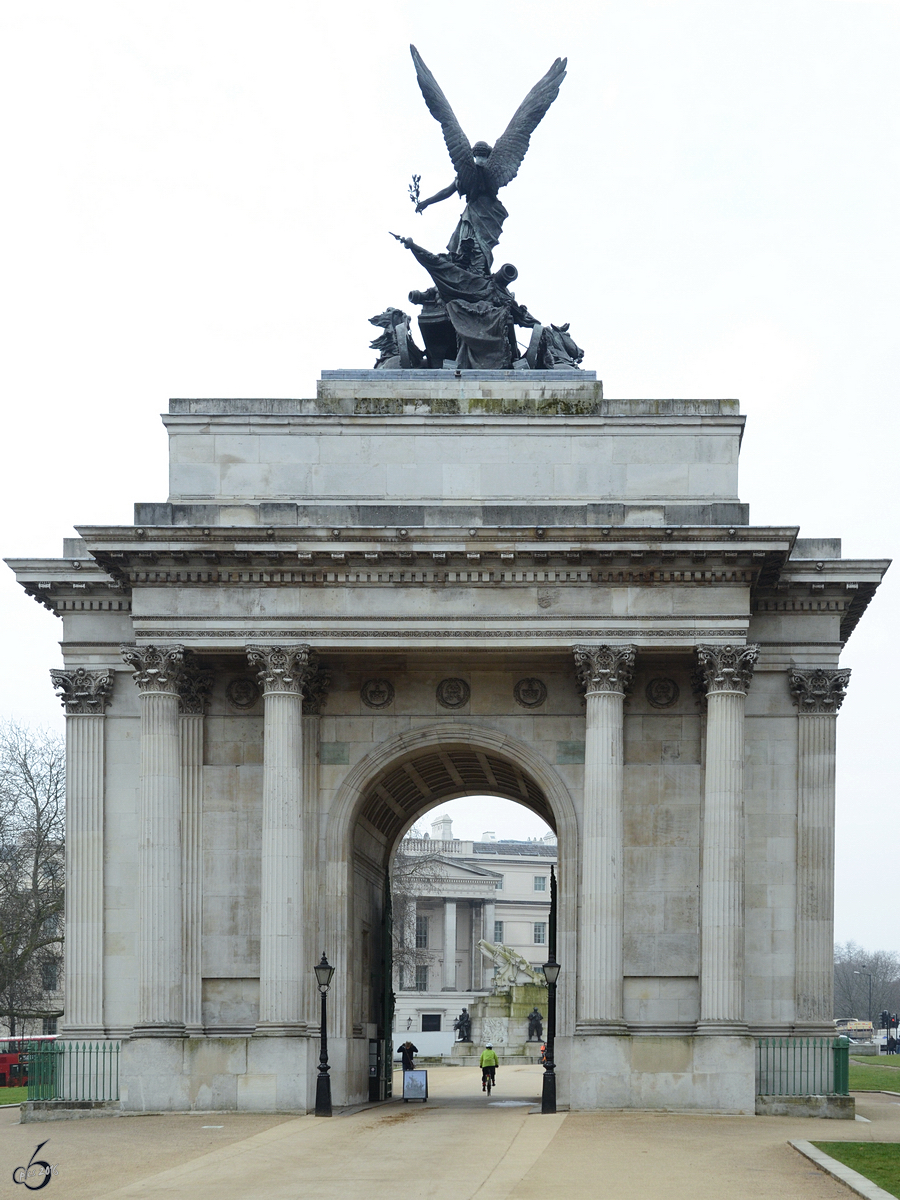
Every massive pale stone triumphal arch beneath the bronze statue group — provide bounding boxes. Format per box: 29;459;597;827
11;370;886;1112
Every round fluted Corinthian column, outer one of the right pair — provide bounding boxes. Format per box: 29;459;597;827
697;646;760;1033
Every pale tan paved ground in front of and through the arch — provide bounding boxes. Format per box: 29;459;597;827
0;1067;900;1200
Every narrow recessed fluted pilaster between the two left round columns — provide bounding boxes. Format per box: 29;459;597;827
179;661;212;1034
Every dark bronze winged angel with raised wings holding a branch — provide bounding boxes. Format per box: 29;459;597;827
409;46;566;275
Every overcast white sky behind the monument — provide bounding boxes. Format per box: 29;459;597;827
0;0;900;950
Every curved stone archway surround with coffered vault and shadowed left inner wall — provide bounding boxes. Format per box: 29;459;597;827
320;724;577;1103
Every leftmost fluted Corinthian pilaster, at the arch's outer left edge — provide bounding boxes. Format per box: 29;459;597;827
50;667;113;1038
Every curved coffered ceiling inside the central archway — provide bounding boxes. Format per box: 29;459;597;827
360;744;556;844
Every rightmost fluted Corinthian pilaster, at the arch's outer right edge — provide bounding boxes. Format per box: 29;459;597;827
790;668;850;1034
